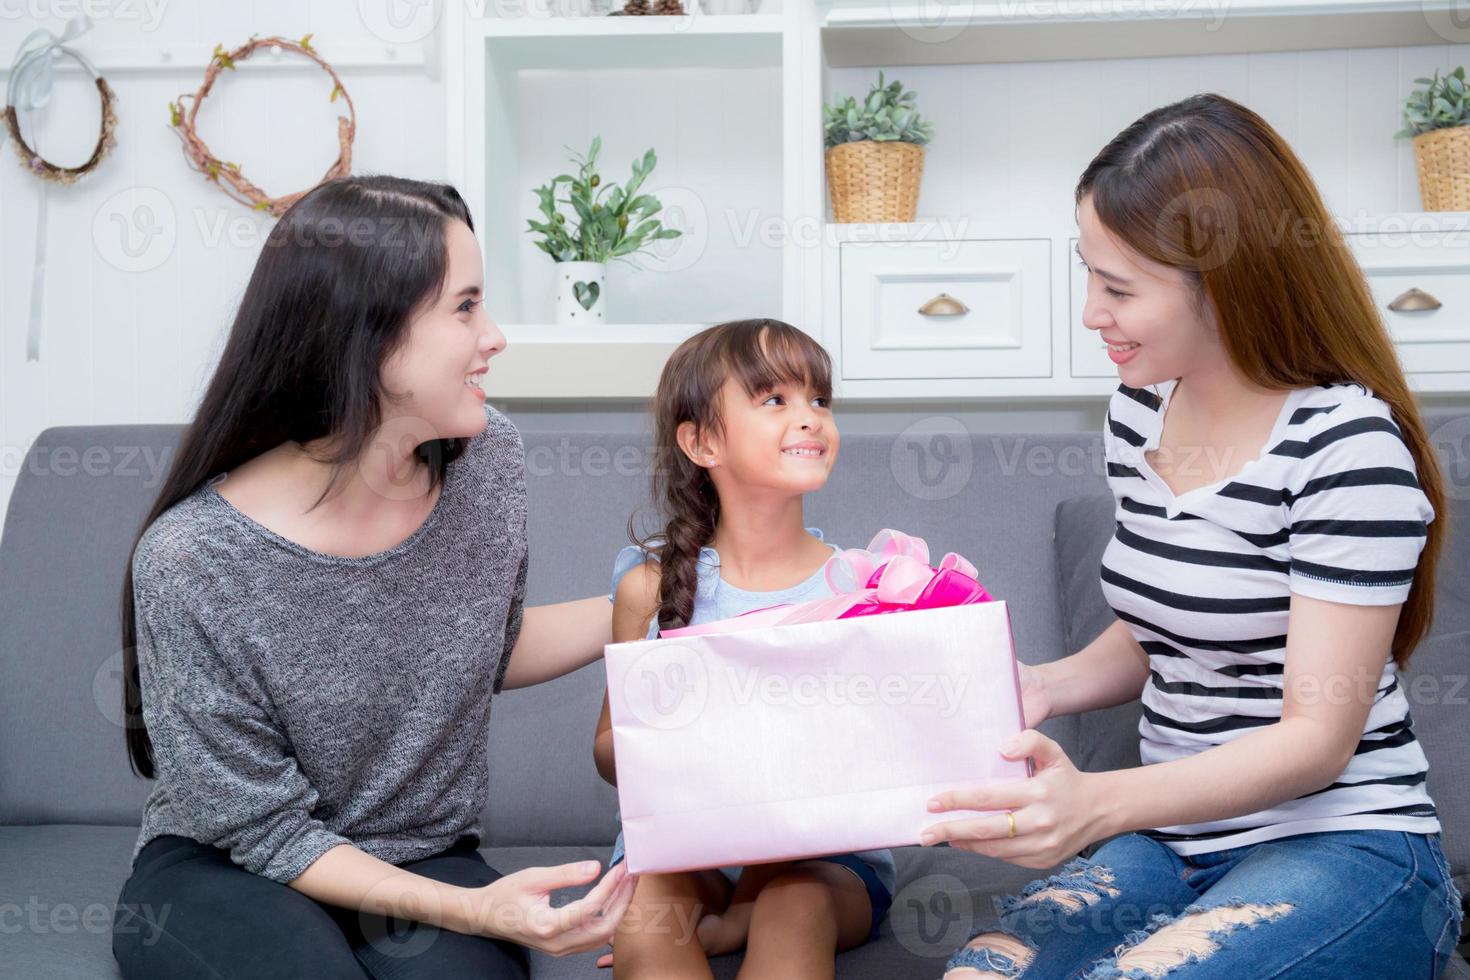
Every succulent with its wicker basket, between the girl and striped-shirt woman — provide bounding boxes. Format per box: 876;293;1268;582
822;72;933;222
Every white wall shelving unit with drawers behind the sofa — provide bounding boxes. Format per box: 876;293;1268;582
441;0;1470;403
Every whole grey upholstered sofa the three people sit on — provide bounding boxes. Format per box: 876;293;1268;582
0;416;1470;979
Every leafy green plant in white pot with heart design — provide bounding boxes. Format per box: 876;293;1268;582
526;137;679;326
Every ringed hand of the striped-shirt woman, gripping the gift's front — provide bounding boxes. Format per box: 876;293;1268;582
920;731;1108;868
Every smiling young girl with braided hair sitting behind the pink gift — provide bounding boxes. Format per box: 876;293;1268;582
592;319;894;977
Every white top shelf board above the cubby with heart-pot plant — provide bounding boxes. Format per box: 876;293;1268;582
475;15;785;69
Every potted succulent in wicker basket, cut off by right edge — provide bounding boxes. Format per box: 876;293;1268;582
1397;65;1470;212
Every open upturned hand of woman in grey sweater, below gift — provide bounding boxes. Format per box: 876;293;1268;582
456;861;638;956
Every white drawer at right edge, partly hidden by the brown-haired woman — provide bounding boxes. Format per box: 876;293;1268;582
1344;231;1470;375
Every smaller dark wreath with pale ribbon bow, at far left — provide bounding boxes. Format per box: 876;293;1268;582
4;18;118;184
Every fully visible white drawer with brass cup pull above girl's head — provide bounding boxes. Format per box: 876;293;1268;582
839;238;1051;381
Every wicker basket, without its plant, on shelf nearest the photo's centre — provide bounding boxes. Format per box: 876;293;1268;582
826;140;925;223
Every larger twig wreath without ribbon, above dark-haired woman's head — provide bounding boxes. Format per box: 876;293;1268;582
169;34;357;217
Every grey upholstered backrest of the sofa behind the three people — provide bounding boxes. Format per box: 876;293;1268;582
0;416;1470;863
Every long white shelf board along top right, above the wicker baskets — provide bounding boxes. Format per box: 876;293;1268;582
822;0;1470;68
